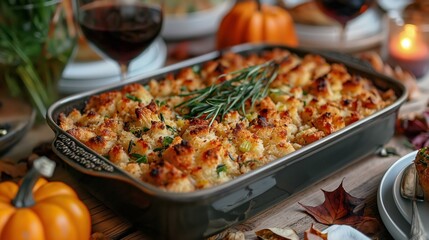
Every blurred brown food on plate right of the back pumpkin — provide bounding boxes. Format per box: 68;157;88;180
289;1;337;26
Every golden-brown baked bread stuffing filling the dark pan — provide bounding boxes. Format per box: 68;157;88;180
59;49;396;192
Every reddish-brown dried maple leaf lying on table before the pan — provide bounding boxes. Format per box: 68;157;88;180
299;182;378;234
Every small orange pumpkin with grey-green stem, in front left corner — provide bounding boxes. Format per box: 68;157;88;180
0;158;91;240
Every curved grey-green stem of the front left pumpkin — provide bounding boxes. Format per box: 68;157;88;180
12;156;55;208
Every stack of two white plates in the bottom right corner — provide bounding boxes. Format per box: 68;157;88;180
377;151;429;239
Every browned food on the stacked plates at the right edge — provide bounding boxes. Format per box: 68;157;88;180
414;147;429;201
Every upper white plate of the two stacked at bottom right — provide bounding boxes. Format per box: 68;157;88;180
393;151;429;225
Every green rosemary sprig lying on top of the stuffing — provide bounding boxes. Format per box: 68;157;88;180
176;61;279;126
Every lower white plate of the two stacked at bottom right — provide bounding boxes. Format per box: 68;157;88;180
377;153;415;240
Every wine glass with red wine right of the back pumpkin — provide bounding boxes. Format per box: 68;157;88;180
314;0;374;47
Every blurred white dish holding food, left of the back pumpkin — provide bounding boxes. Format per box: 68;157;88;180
161;0;234;40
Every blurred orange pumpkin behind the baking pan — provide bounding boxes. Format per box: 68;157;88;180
217;0;298;49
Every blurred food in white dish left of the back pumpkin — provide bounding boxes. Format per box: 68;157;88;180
164;0;225;16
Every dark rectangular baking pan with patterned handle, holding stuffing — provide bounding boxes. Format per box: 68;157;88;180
47;45;407;239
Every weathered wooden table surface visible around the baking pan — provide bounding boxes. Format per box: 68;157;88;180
5;46;429;239
